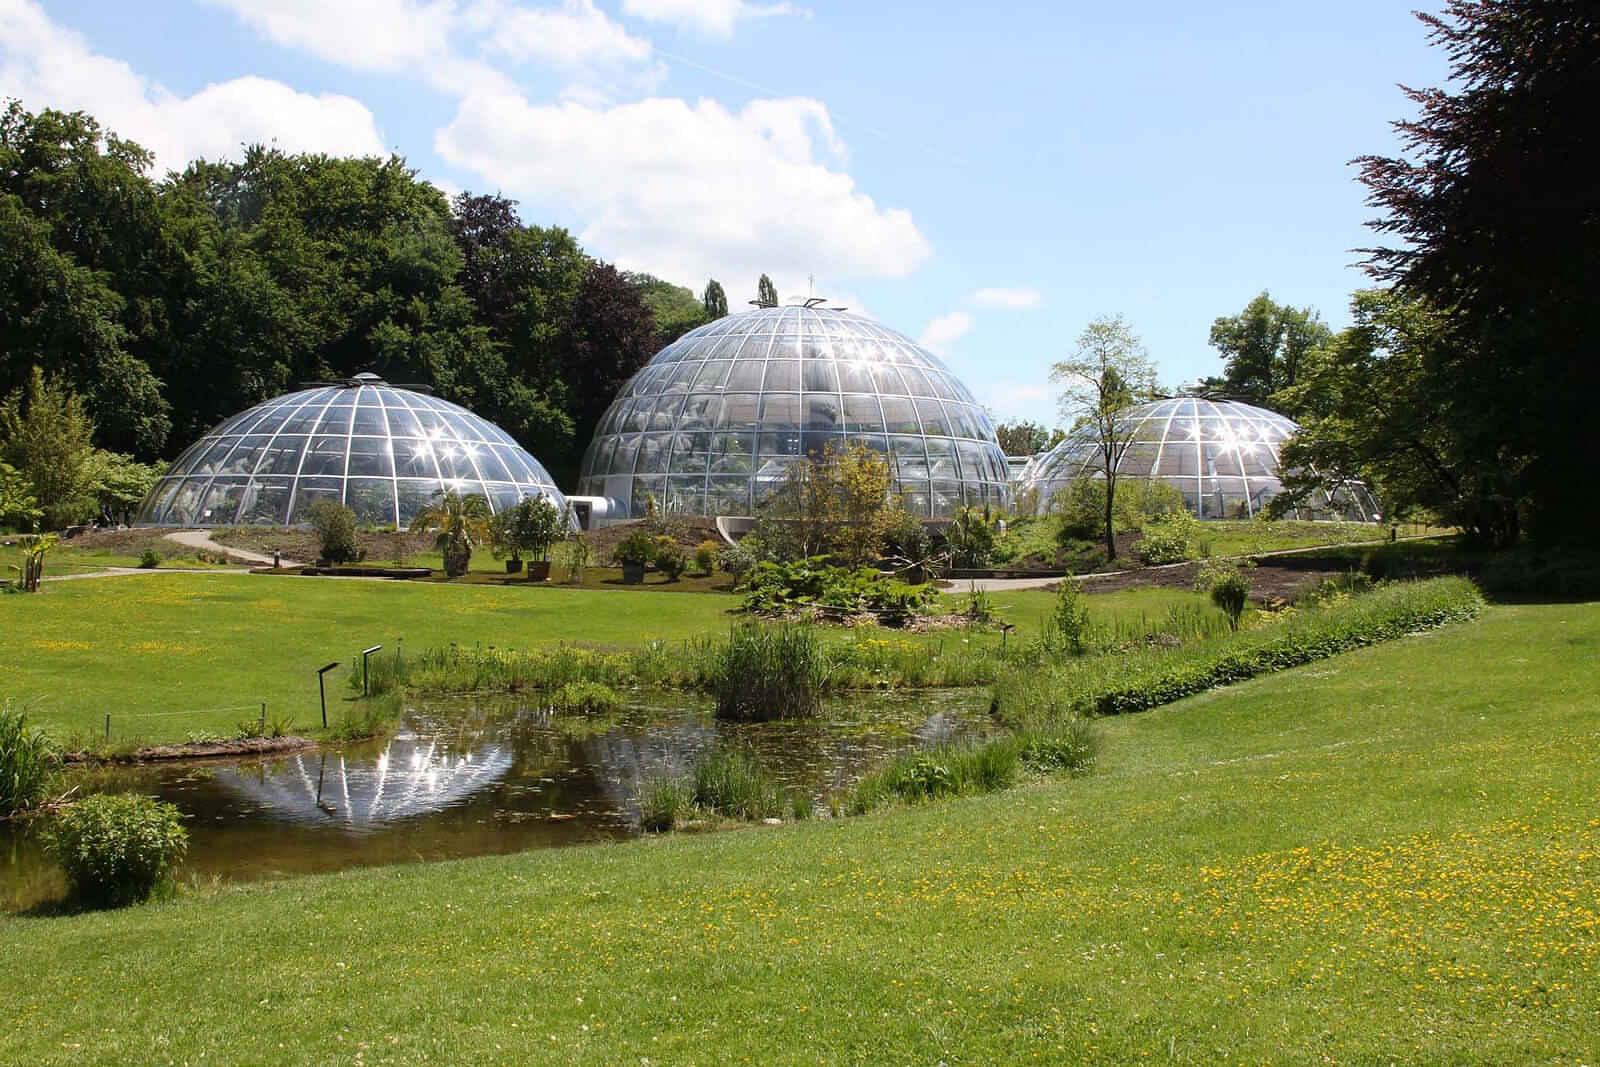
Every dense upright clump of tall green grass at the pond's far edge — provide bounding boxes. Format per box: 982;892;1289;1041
712;624;827;723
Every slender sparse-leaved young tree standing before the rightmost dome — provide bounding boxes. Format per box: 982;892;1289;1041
1050;315;1155;560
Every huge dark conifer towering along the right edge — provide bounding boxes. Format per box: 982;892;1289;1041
1358;0;1600;539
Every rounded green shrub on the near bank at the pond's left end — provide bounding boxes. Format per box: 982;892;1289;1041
45;793;189;907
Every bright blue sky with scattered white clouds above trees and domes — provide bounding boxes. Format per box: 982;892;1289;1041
0;0;1445;422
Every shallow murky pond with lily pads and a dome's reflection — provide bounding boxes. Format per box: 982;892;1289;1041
0;689;990;910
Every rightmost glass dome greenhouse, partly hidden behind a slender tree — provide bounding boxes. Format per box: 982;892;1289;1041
1018;397;1379;522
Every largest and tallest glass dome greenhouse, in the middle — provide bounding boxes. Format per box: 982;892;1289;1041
578;307;1010;518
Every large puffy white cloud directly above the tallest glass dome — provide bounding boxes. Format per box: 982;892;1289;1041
435;96;930;286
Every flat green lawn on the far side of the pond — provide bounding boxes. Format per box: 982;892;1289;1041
0;571;1222;742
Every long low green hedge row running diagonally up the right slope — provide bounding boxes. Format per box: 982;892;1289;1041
990;577;1483;728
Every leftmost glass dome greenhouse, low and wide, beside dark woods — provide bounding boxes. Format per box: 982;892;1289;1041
138;374;565;528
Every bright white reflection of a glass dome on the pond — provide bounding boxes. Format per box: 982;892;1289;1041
218;737;512;827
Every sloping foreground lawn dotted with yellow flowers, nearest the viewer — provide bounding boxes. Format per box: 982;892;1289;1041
0;603;1600;1064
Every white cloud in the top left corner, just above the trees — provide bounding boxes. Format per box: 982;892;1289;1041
0;0;386;173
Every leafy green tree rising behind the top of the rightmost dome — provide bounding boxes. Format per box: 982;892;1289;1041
1208;291;1333;414
